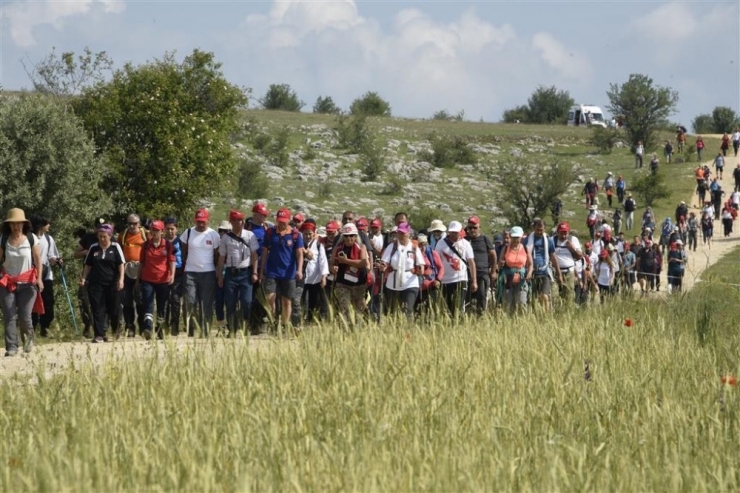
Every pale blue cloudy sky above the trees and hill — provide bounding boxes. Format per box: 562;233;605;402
0;0;740;126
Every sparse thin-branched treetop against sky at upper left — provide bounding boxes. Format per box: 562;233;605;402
21;47;113;97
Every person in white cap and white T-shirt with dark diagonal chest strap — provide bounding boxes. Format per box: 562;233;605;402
434;221;478;316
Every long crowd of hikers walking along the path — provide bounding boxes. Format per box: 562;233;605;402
0;133;740;350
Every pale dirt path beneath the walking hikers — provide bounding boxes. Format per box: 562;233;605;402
5;152;740;378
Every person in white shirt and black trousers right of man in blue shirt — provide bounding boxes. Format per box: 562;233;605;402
301;219;329;322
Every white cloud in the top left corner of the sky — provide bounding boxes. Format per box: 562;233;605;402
0;0;126;47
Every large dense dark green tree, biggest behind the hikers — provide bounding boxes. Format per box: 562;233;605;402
74;50;247;217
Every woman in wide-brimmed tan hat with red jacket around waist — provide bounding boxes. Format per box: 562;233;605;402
0;209;44;356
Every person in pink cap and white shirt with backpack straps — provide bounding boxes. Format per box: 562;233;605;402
380;222;424;319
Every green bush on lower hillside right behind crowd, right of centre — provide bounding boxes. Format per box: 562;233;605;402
489;159;582;229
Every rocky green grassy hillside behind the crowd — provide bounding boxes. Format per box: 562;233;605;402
215;110;718;231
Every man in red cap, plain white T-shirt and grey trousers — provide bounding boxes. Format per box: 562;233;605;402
180;209;221;337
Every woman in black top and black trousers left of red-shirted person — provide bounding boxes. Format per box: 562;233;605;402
80;224;125;342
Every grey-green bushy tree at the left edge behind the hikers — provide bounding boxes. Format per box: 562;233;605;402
0;94;111;238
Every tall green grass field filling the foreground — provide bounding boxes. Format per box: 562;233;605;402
0;278;740;491
